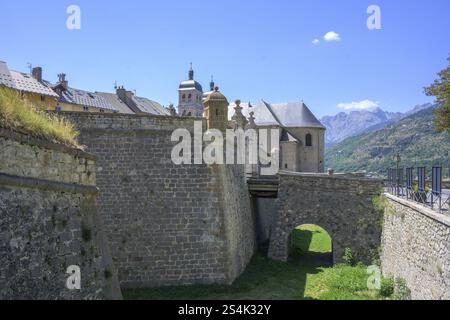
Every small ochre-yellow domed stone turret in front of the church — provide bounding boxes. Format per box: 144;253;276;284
203;87;229;132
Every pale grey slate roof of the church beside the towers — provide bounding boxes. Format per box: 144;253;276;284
228;102;325;129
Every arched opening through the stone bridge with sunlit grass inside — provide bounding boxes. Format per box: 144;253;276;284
289;224;333;267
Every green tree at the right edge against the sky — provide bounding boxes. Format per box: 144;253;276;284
425;54;450;132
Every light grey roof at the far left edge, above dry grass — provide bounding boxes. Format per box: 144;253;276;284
0;61;58;98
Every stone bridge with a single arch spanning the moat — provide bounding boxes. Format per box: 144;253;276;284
249;172;383;263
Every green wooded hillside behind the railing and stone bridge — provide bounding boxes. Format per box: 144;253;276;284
325;108;450;175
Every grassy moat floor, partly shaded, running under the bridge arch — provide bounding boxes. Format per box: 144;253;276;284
124;225;381;300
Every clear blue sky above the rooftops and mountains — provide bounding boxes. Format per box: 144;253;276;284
0;0;450;116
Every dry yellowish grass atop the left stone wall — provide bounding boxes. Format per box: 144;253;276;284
0;86;80;147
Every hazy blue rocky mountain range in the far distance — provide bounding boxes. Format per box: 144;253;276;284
321;104;431;146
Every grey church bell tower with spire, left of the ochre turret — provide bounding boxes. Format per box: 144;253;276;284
178;63;203;117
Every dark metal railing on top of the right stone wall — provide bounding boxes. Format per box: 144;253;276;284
387;167;450;214
